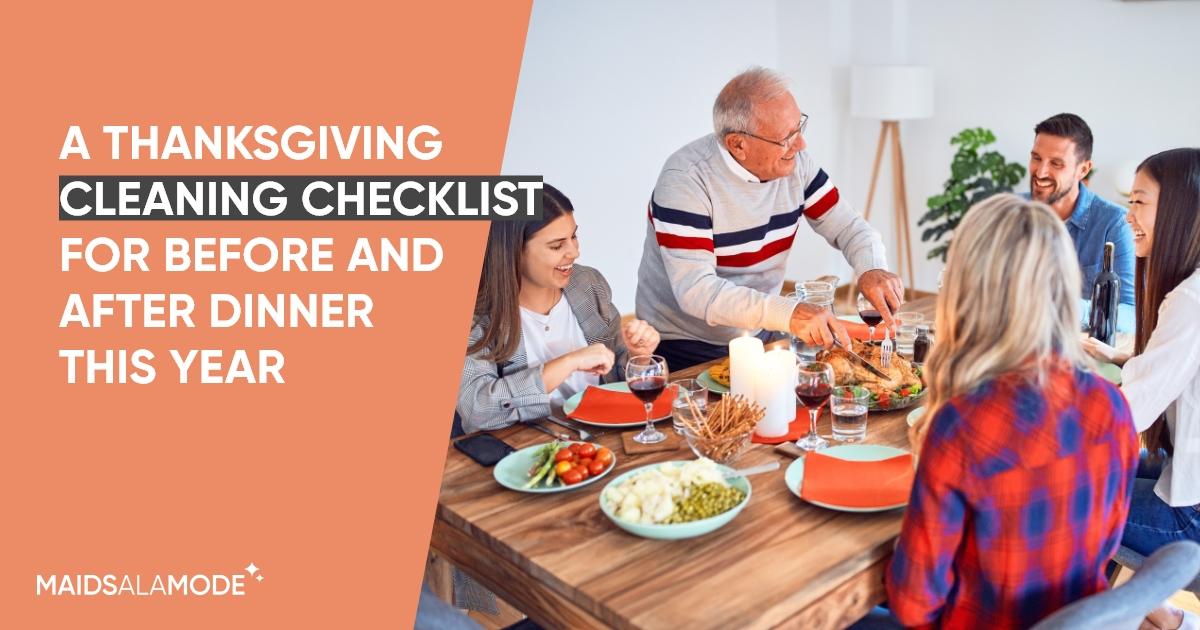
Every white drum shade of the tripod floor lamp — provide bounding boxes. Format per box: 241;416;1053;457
850;66;934;120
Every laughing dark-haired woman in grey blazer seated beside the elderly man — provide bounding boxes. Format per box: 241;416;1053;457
455;185;659;433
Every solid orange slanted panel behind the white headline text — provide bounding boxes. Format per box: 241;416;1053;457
0;0;530;629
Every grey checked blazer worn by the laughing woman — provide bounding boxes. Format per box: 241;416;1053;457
455;264;629;433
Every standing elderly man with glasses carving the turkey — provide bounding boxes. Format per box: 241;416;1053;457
637;67;904;370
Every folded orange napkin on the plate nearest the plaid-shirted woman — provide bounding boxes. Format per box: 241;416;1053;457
800;451;914;508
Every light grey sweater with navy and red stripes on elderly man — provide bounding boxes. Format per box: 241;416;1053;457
637;134;887;344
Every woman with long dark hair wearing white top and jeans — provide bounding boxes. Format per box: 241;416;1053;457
1084;149;1200;556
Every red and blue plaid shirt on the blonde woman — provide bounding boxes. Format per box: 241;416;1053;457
887;365;1138;630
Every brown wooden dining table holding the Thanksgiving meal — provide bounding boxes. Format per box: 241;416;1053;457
430;298;1132;630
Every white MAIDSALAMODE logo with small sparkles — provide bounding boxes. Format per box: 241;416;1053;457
37;563;263;596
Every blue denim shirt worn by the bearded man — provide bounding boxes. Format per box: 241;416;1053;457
1021;182;1135;306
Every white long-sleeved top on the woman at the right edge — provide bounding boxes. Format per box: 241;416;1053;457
1121;269;1200;508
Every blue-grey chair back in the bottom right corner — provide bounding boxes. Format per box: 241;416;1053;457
1030;540;1200;630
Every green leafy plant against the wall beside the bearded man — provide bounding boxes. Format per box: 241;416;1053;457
917;127;1025;260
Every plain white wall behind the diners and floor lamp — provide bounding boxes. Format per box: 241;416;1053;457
504;0;1200;312
